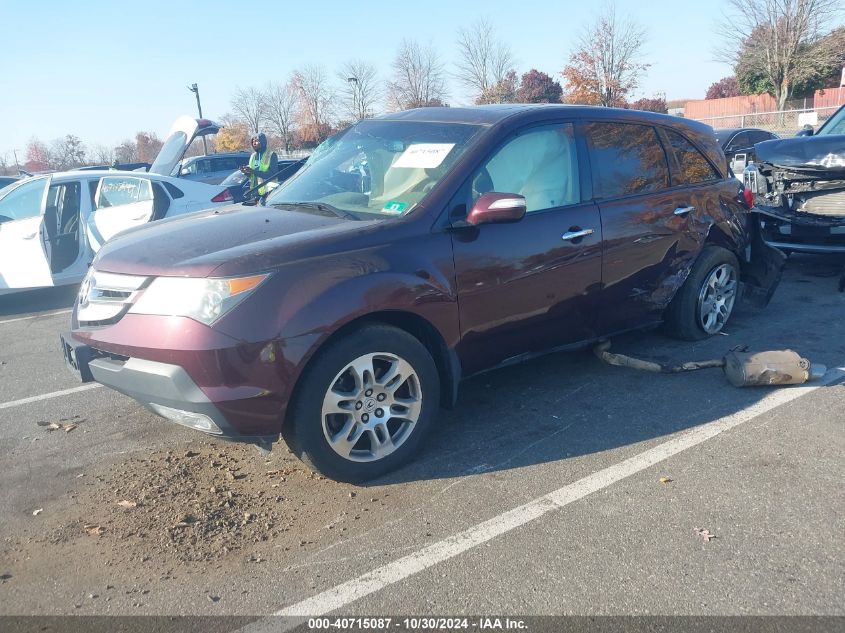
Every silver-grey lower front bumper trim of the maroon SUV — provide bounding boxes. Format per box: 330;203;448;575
61;332;279;443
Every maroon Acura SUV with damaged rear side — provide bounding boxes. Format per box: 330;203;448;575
62;105;782;481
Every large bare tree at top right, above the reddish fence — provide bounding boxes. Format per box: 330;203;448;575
717;0;842;110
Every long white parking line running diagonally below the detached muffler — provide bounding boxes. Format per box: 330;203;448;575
242;367;845;632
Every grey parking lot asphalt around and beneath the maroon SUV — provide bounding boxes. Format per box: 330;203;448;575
0;257;845;616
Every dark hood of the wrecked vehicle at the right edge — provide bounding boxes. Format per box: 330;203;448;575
754;134;845;173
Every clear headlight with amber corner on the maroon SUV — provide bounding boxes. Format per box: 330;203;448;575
129;275;270;325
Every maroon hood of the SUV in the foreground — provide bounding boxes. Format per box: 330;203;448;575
94;205;380;277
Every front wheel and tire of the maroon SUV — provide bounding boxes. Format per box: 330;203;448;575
284;325;440;483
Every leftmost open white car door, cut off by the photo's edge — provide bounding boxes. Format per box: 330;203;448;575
0;176;53;294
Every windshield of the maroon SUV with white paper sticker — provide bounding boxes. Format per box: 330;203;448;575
267;120;484;216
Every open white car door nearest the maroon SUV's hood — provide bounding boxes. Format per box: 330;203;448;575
86;175;155;252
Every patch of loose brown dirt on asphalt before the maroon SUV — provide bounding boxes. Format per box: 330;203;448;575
29;444;389;566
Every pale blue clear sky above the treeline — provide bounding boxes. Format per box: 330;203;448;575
0;0;732;163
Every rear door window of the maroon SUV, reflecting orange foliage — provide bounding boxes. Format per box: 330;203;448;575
585;123;669;199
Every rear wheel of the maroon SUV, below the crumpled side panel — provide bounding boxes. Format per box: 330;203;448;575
665;246;739;341
